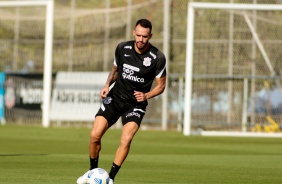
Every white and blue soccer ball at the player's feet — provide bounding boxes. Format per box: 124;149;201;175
87;168;110;184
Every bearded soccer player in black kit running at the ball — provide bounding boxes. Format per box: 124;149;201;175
77;19;166;184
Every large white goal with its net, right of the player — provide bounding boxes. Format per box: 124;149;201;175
184;3;282;135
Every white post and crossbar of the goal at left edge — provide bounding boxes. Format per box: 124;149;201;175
0;0;54;127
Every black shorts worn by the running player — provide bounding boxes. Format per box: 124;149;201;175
95;93;147;127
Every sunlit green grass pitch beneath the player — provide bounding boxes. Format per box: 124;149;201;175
0;125;282;184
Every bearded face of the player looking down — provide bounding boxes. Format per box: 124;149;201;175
133;25;152;50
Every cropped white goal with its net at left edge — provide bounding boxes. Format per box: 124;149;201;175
0;0;54;126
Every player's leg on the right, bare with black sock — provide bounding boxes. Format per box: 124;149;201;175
109;122;139;180
